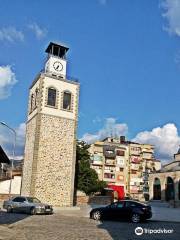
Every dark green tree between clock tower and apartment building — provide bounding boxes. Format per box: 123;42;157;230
75;141;106;195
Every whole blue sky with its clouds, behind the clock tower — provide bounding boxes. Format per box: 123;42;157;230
0;0;180;159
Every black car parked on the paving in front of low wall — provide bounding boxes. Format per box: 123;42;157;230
90;200;152;223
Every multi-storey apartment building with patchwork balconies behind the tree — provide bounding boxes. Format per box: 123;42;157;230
89;136;161;200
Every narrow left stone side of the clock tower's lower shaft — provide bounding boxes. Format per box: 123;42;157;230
21;117;36;196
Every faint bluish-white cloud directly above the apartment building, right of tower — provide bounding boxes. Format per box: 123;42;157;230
81;118;128;143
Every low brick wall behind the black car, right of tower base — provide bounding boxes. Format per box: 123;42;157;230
76;196;113;206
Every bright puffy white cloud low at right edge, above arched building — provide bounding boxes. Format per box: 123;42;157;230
133;123;180;160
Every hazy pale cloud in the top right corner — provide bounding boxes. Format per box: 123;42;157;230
161;0;180;37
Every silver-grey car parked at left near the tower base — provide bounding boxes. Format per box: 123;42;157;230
3;196;53;215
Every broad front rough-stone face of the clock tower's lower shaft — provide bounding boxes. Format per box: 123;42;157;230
31;114;76;206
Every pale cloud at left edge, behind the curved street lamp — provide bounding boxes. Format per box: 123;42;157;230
0;123;26;159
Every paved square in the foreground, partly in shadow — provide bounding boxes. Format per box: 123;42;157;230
0;212;180;240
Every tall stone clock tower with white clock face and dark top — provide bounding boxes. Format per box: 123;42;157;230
21;42;79;206
